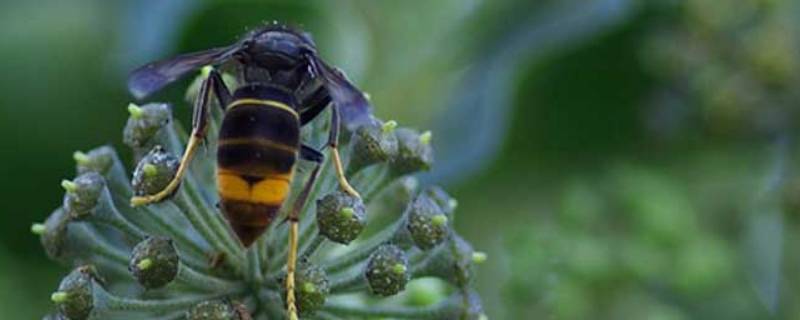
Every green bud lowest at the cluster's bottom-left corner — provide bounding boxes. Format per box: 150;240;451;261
50;266;98;320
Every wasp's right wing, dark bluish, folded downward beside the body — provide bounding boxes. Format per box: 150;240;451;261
311;56;372;130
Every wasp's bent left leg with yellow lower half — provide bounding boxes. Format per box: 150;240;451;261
131;70;231;206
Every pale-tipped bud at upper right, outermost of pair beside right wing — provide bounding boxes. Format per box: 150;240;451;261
391;128;433;175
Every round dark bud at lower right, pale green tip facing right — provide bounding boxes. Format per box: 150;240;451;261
364;245;410;297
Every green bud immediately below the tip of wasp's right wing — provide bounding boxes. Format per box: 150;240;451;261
348;120;397;173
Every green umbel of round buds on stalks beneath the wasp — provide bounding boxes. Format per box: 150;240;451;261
31;69;485;320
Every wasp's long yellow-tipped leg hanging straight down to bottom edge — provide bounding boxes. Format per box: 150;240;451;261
286;154;323;320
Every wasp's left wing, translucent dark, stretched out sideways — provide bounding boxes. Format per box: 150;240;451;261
128;44;240;99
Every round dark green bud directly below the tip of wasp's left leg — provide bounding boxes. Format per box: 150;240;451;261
128;237;179;289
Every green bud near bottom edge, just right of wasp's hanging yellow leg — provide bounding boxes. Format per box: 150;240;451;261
282;263;330;316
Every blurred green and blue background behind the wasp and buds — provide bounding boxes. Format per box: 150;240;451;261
0;0;800;319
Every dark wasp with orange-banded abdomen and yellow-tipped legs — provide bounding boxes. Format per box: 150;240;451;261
128;23;371;319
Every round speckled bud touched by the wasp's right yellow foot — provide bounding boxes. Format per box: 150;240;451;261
317;191;366;244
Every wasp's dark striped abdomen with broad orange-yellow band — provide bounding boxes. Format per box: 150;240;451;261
217;93;300;247
